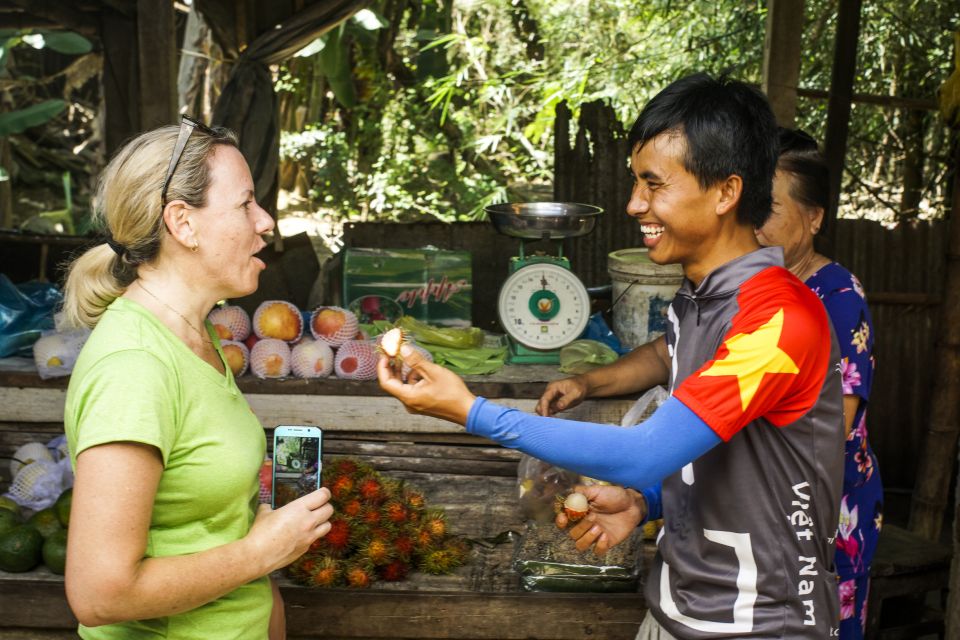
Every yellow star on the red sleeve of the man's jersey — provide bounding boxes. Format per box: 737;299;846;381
700;308;800;411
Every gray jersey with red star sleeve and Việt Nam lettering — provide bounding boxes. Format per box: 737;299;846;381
646;248;844;639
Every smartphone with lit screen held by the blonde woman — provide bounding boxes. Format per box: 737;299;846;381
271;425;323;509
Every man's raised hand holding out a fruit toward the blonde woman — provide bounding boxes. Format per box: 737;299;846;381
377;344;477;424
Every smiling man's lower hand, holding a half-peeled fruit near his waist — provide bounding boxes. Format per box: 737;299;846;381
556;485;647;556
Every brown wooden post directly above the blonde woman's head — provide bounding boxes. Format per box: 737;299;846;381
137;0;177;130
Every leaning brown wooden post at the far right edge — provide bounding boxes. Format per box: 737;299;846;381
910;136;960;540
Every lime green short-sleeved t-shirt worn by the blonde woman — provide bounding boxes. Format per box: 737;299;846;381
64;298;273;640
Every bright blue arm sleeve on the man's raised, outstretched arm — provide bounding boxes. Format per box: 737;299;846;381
467;398;721;489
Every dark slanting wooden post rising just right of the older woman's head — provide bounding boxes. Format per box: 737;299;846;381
824;0;861;255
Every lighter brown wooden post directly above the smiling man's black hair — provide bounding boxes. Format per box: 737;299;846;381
761;0;803;127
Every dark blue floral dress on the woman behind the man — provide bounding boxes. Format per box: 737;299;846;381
806;262;883;640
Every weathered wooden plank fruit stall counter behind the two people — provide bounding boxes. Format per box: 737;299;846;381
0;361;645;640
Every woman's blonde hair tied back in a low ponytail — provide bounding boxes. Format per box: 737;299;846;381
63;126;237;328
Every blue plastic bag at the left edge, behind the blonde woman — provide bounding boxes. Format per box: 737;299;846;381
0;273;63;358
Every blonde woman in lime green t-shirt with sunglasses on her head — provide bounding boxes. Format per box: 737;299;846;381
64;117;332;640
